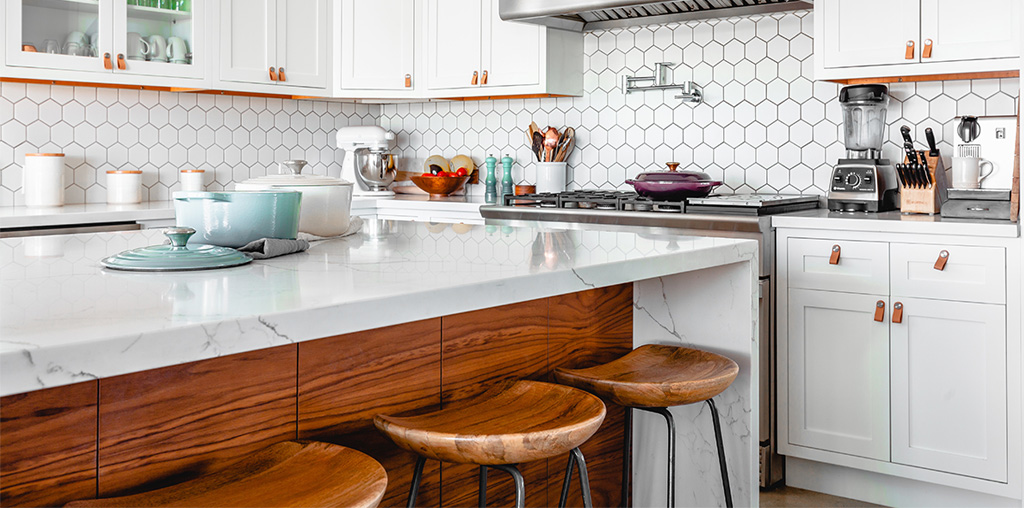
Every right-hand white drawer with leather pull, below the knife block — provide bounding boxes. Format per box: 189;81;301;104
890;243;1007;303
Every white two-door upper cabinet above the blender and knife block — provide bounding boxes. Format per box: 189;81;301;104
813;0;1020;80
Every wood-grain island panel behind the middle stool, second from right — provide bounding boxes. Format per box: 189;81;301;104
441;299;557;507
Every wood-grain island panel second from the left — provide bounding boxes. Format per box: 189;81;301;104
98;345;297;497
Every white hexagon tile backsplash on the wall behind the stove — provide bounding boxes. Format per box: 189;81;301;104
381;10;1018;195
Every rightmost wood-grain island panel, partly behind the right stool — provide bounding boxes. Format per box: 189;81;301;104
548;284;633;506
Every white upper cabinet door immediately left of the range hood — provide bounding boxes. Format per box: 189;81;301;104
480;0;547;86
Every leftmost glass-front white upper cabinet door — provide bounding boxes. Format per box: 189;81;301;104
0;0;113;73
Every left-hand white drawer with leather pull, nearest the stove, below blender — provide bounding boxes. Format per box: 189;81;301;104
786;239;889;295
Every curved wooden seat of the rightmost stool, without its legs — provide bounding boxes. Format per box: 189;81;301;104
555;344;739;408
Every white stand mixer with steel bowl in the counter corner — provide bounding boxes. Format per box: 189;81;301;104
337;125;397;198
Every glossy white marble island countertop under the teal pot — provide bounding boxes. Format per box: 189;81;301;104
0;220;757;395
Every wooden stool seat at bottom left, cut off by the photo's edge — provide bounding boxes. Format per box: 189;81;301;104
66;441;387;508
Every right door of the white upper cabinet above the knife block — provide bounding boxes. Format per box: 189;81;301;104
921;0;1020;61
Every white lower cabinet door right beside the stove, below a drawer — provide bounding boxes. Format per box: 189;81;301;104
787;289;889;461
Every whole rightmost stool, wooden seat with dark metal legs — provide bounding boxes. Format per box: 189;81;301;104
555;344;739;508
